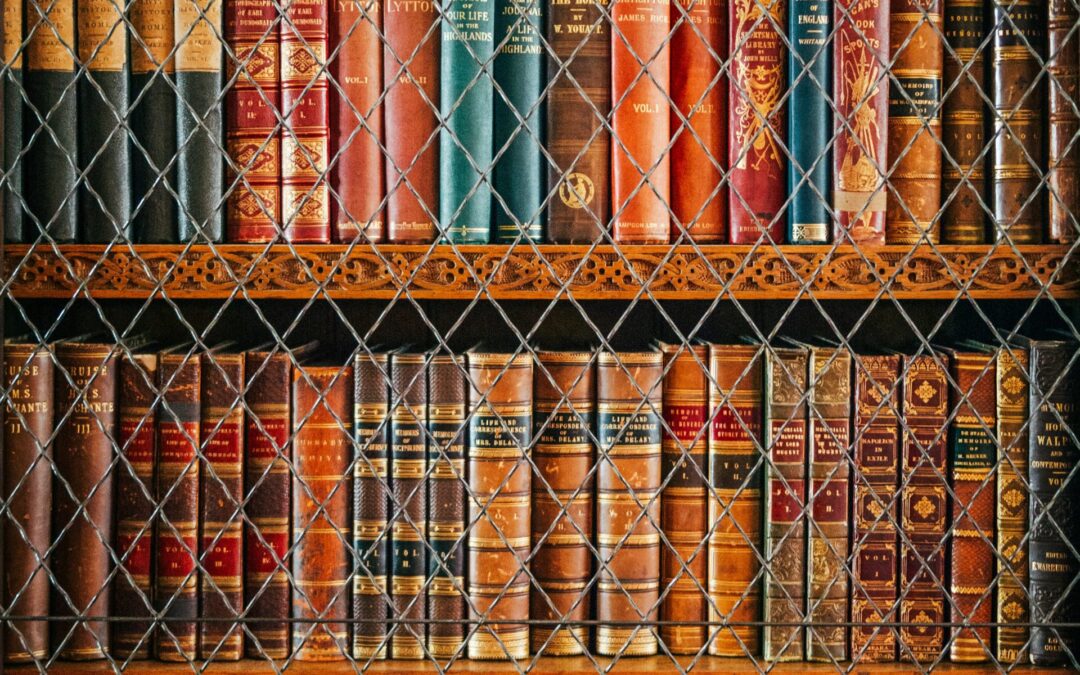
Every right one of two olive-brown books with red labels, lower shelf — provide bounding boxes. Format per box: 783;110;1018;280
807;348;851;663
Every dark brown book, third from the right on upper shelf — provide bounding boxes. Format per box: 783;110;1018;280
942;0;989;244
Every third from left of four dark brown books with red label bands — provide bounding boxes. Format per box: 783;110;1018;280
199;353;244;661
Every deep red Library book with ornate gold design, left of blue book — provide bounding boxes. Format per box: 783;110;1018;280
728;0;788;244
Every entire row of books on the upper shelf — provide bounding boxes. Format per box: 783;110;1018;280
2;0;1080;244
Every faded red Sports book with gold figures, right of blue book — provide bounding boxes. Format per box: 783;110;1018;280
833;0;890;245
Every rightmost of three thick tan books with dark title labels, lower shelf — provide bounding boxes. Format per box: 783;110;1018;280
596;352;663;657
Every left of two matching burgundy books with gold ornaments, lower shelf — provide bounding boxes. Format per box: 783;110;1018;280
851;355;901;663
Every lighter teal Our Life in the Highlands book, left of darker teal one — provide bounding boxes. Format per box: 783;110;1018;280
438;0;495;244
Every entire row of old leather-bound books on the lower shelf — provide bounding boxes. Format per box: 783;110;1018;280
3;340;1080;664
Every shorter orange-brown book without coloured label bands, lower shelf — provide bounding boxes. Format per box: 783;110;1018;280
291;362;352;661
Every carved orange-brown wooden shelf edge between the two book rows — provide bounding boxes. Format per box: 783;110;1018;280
3;244;1080;300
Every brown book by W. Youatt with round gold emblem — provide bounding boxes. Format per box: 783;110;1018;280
545;0;611;244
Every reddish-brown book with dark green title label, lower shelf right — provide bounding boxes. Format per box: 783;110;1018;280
949;352;997;663
